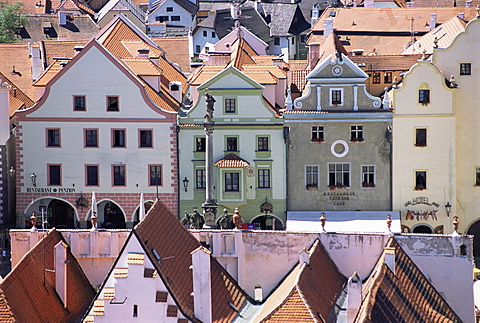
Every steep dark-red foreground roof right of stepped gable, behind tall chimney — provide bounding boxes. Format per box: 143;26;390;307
133;200;248;323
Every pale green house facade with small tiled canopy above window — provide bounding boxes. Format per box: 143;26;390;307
179;66;285;229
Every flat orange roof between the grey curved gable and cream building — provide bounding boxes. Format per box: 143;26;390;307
348;54;422;72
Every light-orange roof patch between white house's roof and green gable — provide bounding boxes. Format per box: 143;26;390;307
152;36;190;73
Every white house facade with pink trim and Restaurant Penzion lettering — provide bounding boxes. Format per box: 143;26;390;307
16;39;177;228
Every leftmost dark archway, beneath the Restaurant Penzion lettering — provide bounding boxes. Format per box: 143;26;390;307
24;196;80;229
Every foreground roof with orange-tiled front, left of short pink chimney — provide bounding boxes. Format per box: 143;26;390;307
258;239;347;322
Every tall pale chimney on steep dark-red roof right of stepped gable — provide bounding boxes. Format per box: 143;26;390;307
191;247;212;323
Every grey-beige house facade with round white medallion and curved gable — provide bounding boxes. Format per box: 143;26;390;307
283;52;392;225
